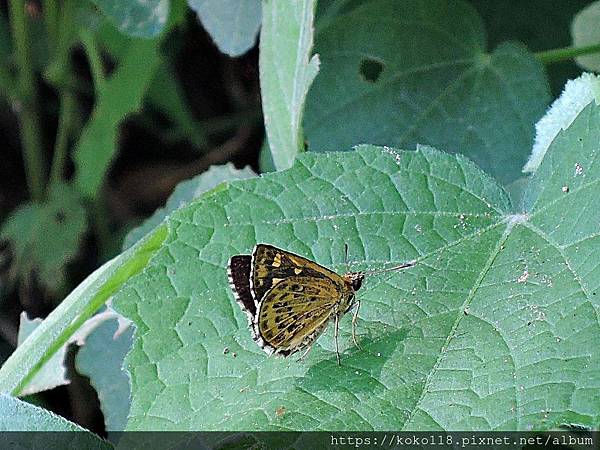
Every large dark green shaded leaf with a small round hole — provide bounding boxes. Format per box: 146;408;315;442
304;0;549;183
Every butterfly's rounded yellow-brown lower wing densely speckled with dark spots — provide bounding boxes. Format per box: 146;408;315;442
254;276;348;356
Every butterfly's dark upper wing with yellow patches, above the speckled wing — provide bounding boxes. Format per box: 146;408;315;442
250;244;344;305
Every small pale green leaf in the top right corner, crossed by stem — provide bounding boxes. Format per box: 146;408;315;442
571;1;600;72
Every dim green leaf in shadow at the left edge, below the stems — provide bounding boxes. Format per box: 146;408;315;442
0;184;87;291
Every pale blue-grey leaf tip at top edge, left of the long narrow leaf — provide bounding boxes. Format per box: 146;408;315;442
188;0;261;56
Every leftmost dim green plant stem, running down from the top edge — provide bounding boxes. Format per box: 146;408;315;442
9;0;45;201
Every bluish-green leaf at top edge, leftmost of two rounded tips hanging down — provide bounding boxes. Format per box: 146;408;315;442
92;0;170;38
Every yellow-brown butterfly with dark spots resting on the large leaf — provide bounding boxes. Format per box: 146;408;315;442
228;244;415;364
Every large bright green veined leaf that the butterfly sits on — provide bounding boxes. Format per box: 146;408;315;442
110;105;600;430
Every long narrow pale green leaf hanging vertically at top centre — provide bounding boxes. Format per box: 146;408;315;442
259;0;319;170
